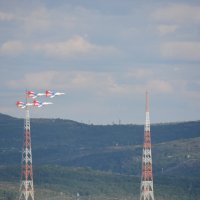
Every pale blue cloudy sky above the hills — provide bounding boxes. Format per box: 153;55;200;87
0;0;200;124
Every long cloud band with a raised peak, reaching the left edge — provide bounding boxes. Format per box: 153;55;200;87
0;36;119;58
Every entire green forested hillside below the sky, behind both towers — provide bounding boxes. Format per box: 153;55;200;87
0;114;200;200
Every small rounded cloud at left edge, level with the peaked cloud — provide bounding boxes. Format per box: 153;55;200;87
0;41;25;55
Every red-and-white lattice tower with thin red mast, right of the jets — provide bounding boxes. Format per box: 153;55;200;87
140;92;154;200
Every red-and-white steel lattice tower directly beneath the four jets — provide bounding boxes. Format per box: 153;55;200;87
19;106;34;200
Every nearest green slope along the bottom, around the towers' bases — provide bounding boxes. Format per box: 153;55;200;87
0;166;200;200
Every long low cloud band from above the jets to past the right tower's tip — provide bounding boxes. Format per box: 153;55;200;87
7;71;173;98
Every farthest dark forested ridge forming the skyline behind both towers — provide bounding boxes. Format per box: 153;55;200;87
0;114;200;148
